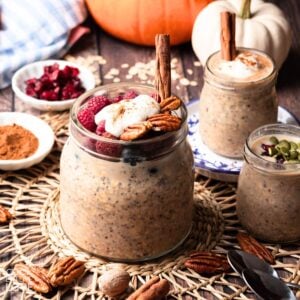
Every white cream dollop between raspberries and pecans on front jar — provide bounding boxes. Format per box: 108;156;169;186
95;95;160;137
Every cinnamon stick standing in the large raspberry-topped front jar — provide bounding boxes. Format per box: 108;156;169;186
155;34;171;100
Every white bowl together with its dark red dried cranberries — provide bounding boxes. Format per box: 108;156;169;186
12;60;95;111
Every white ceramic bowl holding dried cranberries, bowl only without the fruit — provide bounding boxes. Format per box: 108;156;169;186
12;60;95;111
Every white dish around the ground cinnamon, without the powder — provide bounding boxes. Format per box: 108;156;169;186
0;112;54;171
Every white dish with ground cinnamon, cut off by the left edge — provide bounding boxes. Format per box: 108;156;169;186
0;112;54;171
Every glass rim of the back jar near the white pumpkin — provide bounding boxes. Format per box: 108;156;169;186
204;47;278;90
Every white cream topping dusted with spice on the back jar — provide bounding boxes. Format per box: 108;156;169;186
218;53;263;79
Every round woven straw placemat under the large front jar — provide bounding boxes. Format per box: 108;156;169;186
0;113;300;299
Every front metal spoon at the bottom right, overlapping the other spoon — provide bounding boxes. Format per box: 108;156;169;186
242;269;296;300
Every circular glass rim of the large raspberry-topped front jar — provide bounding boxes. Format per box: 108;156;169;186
70;82;187;146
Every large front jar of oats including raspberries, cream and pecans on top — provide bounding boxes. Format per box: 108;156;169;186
60;84;193;261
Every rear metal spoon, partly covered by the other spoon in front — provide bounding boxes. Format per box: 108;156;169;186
227;250;300;289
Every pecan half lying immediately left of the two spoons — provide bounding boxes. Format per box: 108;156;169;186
184;252;230;275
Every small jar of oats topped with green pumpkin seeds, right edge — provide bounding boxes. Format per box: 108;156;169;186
237;124;300;243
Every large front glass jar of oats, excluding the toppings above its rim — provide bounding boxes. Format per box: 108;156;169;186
60;83;193;262
